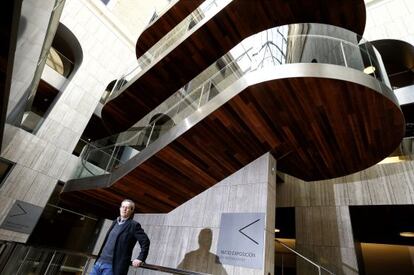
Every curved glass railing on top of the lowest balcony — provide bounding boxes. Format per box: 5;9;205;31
74;24;387;179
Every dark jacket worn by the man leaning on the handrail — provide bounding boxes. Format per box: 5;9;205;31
98;219;150;275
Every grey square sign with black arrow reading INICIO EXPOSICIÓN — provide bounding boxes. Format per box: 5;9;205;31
217;213;265;269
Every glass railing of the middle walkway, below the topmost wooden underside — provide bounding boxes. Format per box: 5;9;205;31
108;0;232;100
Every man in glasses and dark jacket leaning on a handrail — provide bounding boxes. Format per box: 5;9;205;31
91;200;150;275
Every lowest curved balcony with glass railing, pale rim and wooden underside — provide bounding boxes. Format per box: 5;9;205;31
62;24;404;218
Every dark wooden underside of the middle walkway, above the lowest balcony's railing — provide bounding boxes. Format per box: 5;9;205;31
102;0;365;133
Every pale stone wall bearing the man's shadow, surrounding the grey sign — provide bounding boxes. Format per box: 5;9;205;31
130;154;276;275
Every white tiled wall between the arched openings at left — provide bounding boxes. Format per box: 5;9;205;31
0;0;136;242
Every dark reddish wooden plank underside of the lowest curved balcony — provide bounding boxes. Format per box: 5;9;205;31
62;77;404;218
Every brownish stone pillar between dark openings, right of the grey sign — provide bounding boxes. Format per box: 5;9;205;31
296;206;358;274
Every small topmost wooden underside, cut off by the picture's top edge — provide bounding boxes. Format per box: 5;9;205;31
136;0;205;58
